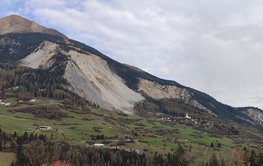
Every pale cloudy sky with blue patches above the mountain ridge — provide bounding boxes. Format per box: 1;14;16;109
0;0;263;108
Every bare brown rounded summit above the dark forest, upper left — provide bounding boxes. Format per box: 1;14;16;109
0;15;67;38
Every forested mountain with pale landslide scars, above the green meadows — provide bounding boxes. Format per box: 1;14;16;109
0;16;263;130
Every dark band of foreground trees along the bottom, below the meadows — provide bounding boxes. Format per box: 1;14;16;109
0;129;188;166
